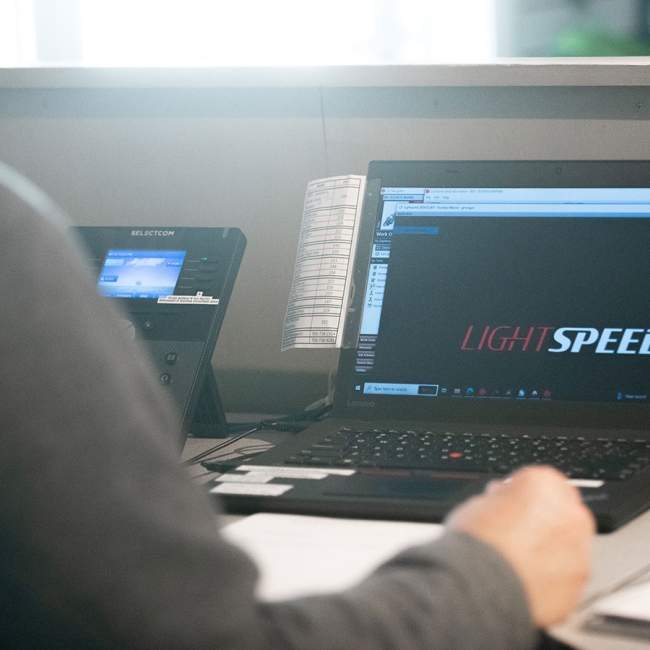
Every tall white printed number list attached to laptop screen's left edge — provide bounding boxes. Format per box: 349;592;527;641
282;175;366;350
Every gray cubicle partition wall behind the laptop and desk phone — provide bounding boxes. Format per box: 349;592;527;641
0;66;650;412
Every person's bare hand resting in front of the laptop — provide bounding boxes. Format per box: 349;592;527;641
446;467;595;628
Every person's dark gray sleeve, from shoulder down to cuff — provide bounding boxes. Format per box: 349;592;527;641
0;167;536;650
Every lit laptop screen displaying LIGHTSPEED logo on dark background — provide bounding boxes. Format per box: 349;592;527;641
353;187;650;404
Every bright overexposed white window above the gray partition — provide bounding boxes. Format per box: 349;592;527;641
0;0;496;67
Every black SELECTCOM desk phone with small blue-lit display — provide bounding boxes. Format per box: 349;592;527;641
73;226;246;443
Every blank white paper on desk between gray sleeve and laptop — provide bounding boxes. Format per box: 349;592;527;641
223;513;443;600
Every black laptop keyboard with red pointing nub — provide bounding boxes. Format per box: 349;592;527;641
286;428;650;480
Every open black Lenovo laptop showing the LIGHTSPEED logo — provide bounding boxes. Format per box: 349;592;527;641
213;161;650;531
